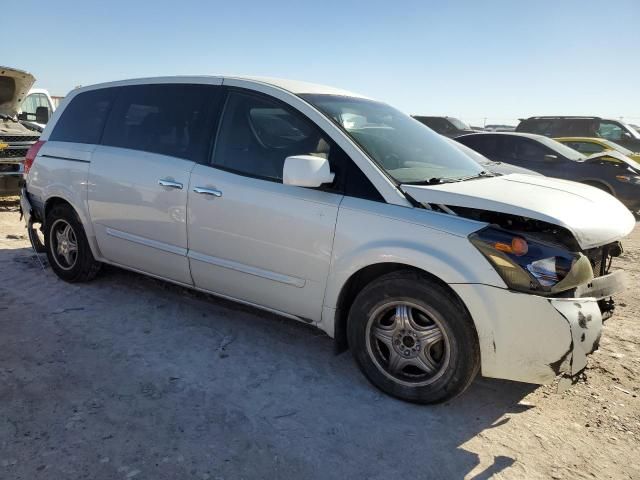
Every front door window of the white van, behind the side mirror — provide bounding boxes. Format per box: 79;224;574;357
212;92;331;181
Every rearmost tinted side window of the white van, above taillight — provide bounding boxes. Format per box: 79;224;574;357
49;88;116;143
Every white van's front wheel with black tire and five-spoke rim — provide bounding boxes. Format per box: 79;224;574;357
347;270;480;404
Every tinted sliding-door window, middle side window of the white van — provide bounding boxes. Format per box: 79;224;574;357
102;84;219;161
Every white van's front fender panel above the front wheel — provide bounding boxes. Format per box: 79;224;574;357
320;197;506;335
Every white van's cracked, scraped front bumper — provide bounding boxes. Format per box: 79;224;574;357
451;272;625;384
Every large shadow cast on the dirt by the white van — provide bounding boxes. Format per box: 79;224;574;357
0;249;535;479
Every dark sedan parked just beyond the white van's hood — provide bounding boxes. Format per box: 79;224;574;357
456;133;640;212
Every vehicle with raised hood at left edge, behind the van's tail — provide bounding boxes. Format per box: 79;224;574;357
0;67;41;195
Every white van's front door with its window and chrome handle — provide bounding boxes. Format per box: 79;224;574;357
188;90;342;321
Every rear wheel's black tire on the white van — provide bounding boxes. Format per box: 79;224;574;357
44;204;101;283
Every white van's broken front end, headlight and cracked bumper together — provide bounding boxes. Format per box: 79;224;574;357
452;210;626;384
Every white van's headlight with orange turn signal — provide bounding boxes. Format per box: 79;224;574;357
469;227;593;295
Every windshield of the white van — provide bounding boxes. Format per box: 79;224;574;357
301;94;483;183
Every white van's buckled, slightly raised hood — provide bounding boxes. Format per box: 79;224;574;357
401;174;635;249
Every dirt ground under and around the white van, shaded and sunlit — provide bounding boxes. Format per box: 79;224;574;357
0;196;640;480
